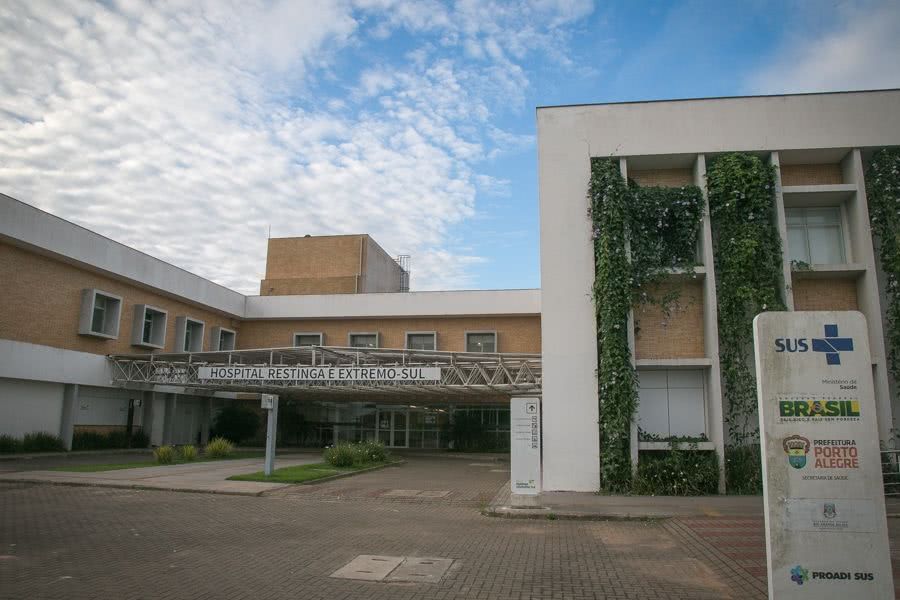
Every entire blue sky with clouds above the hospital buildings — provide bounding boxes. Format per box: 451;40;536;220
0;0;900;293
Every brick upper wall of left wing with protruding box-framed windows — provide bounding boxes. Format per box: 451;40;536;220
0;243;241;354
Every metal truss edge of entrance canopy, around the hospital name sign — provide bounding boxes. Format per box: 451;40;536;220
109;346;541;398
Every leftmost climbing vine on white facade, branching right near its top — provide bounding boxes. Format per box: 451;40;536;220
588;158;703;492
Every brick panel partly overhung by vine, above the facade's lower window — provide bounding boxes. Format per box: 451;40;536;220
634;281;705;359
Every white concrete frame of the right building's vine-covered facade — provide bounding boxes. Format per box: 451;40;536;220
537;90;900;491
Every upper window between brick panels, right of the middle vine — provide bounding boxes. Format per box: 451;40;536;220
785;207;846;265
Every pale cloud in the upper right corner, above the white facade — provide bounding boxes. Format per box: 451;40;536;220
747;0;900;93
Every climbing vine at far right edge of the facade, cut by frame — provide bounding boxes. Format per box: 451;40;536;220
866;148;900;386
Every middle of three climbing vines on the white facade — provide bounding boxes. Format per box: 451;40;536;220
707;154;784;454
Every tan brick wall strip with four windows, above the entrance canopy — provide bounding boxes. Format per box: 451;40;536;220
238;315;541;352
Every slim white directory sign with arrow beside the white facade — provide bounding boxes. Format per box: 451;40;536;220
509;396;541;504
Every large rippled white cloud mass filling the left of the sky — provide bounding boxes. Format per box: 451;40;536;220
0;0;585;293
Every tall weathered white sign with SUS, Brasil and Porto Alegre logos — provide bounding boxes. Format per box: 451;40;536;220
753;312;894;600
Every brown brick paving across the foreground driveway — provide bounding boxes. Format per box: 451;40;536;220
0;459;900;600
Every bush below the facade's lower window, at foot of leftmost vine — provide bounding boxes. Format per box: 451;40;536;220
632;443;719;496
